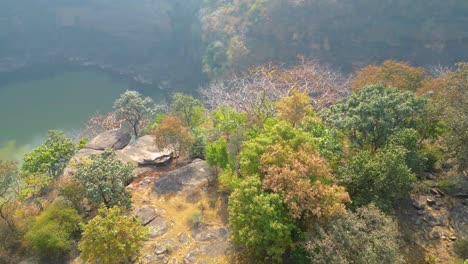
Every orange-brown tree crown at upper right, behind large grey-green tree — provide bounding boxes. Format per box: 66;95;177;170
351;60;426;91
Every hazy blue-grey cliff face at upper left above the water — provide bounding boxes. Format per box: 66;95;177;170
0;0;202;87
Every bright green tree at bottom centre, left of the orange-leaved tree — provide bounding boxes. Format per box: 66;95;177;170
228;177;295;262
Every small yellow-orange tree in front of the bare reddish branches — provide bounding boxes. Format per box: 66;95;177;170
276;90;313;127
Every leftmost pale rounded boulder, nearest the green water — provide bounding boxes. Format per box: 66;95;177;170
85;129;132;150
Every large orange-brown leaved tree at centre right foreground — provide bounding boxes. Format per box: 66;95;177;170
260;144;351;219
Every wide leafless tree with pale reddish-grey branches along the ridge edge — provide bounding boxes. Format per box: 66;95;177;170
201;61;351;121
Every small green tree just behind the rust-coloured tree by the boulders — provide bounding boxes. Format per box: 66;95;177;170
171;93;205;130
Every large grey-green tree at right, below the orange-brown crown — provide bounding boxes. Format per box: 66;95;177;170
322;85;427;150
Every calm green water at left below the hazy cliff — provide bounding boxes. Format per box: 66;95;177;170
0;71;129;159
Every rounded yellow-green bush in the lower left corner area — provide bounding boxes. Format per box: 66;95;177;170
25;203;82;261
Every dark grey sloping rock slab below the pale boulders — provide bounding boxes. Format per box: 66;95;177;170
153;160;215;194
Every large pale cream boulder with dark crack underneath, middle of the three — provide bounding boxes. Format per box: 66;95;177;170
116;135;173;166
